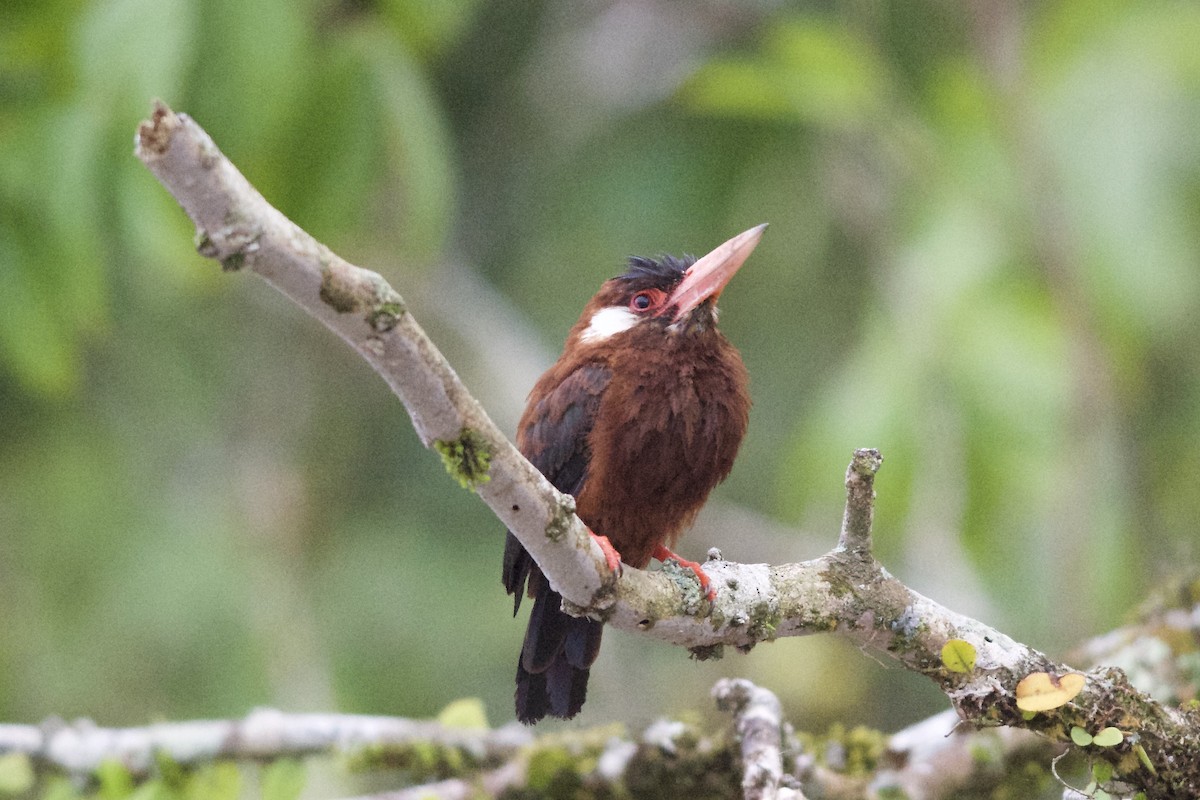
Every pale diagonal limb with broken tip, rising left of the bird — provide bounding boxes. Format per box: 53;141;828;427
136;103;613;608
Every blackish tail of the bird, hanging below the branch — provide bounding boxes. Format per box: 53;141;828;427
516;576;604;724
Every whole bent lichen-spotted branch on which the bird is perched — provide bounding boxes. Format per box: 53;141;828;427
136;103;1200;798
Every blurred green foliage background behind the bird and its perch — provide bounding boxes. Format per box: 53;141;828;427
0;0;1200;743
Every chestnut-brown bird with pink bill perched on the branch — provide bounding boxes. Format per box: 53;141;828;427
503;224;767;724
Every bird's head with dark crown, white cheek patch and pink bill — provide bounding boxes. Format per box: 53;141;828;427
572;223;767;344
